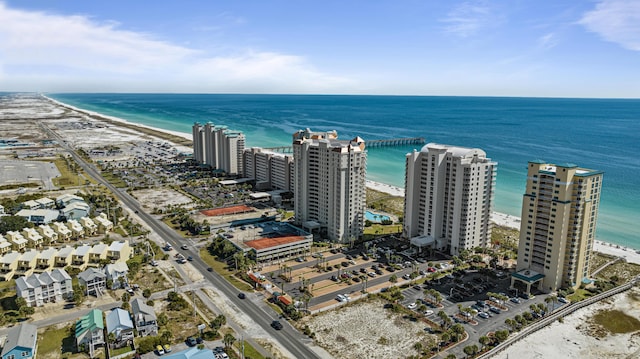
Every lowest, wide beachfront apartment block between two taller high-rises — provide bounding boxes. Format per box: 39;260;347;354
243;147;294;191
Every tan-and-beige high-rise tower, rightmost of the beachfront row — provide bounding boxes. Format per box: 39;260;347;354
512;161;603;292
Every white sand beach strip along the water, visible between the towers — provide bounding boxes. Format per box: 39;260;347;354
40;94;640;258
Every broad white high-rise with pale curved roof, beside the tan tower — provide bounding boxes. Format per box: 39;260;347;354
404;143;498;255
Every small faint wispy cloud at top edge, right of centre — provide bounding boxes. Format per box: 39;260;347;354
441;1;493;37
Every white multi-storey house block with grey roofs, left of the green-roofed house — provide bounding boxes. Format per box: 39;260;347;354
16;268;73;307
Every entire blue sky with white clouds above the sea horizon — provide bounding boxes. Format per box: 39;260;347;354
0;0;640;98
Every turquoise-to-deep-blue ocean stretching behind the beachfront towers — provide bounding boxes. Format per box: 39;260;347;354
48;93;640;249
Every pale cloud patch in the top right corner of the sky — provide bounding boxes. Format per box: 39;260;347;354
579;0;640;51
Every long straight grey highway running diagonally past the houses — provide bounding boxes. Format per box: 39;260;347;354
42;125;320;358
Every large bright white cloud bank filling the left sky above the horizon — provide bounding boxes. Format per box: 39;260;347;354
0;2;351;92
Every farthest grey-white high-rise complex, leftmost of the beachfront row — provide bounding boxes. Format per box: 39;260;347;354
192;122;245;176
